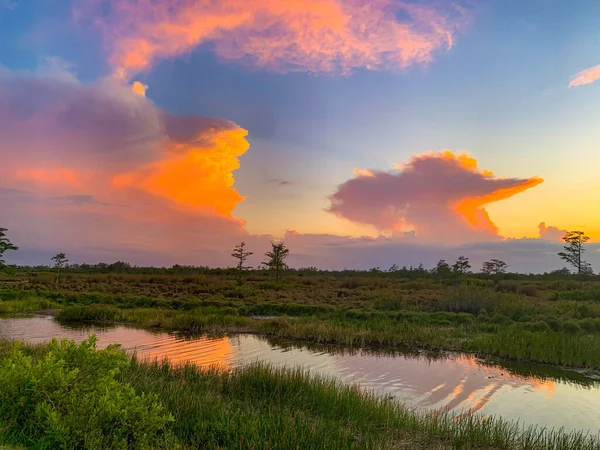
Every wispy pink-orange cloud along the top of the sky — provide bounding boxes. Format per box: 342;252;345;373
74;0;469;77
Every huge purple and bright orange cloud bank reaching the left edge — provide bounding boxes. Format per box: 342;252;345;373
0;68;249;263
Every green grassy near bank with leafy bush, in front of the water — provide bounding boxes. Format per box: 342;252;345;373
0;340;600;450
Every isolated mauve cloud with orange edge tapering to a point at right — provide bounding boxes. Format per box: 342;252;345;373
328;150;543;242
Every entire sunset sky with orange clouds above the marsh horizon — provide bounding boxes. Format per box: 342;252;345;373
0;0;600;273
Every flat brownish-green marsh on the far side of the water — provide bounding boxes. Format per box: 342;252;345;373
0;274;600;369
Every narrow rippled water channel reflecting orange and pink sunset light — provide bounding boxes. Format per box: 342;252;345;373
0;317;600;434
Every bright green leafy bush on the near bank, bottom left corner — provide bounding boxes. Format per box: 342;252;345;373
0;336;173;449
